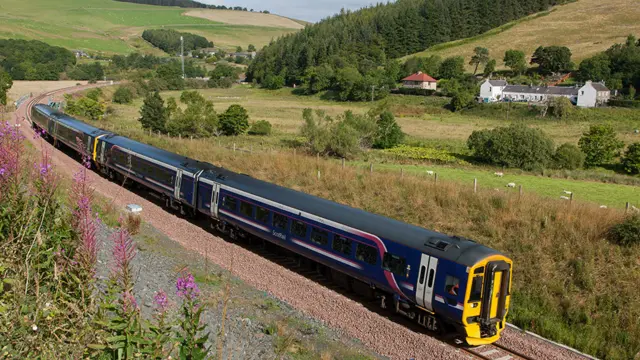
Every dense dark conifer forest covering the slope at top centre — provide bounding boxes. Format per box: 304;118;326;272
247;0;568;84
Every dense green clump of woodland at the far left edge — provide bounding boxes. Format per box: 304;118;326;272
0;39;76;80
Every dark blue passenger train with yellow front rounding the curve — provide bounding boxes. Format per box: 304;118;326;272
31;104;513;346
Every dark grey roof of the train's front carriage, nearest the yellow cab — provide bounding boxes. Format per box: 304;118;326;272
201;167;500;266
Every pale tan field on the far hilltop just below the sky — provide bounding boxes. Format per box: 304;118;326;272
184;9;304;29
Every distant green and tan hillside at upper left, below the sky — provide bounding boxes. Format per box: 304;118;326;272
0;0;301;53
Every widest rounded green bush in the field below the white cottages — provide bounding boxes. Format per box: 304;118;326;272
467;124;555;170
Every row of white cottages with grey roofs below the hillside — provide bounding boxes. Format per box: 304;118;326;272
480;80;610;107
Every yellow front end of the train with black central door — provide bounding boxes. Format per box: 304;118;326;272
462;255;512;346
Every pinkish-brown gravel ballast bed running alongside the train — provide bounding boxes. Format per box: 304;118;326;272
16;87;592;359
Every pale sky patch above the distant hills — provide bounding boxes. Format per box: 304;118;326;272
198;0;377;22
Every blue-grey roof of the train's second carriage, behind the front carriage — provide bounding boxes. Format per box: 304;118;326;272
103;134;216;174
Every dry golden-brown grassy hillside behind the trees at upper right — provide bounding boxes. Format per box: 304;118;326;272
407;0;640;70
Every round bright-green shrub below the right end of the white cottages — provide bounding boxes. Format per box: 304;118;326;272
578;125;624;166
